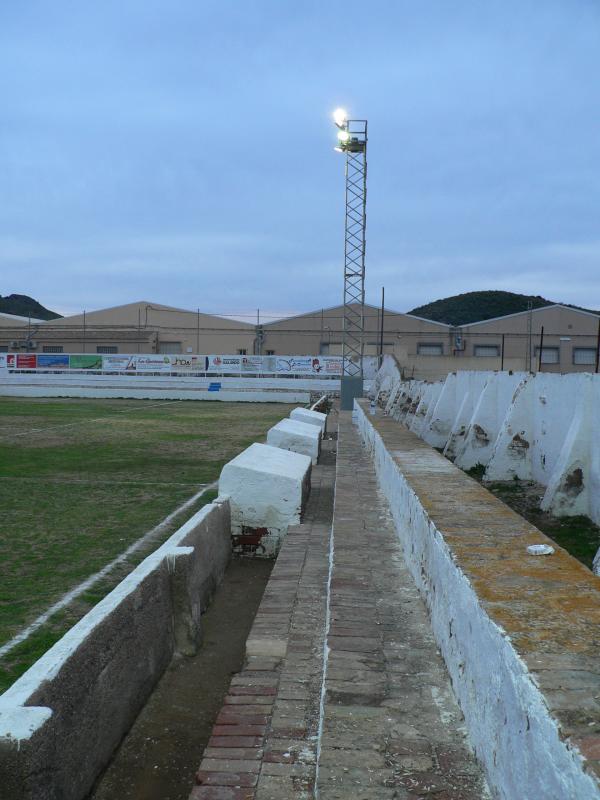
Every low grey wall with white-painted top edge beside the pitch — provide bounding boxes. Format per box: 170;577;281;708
0;497;231;800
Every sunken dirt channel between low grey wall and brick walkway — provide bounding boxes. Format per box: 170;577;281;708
89;558;273;800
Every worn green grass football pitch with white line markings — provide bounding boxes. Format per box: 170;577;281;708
0;398;289;691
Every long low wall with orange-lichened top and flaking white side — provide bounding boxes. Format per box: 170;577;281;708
354;401;600;800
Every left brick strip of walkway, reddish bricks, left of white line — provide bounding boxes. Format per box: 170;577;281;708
190;440;336;800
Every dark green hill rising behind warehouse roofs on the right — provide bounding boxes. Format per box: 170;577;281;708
408;290;555;325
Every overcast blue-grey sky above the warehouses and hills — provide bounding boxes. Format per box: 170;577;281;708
0;0;600;315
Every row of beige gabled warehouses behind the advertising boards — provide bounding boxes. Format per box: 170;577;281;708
0;301;600;379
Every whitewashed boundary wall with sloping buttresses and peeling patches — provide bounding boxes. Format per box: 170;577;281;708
374;359;600;523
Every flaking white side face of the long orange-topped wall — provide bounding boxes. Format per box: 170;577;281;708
354;404;600;800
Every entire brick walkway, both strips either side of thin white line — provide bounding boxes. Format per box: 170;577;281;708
190;412;488;800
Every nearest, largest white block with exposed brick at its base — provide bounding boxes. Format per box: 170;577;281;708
219;444;310;556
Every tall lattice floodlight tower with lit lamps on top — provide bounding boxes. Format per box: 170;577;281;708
333;108;367;410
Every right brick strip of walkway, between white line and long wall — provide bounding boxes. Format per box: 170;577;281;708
317;412;487;800
